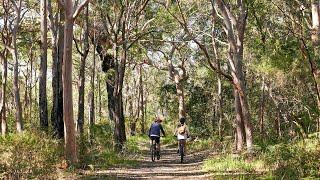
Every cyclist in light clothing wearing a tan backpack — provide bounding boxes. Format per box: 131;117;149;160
174;117;190;155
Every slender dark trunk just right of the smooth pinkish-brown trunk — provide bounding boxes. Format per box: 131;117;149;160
78;6;89;135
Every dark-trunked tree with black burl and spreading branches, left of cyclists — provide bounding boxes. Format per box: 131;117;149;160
95;0;152;150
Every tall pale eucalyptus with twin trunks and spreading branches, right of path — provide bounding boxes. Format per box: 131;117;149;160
160;0;253;152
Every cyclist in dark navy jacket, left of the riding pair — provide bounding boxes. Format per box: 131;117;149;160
149;116;165;159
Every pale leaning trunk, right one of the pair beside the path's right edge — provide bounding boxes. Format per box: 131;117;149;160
215;0;253;153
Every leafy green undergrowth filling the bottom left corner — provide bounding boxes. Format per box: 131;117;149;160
0;131;62;179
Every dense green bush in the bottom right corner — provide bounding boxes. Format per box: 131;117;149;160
265;139;320;179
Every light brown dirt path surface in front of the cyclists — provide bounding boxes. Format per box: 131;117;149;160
80;146;218;179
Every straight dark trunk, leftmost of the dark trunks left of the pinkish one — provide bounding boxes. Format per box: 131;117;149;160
39;0;48;130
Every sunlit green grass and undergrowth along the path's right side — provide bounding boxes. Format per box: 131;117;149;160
204;136;320;179
